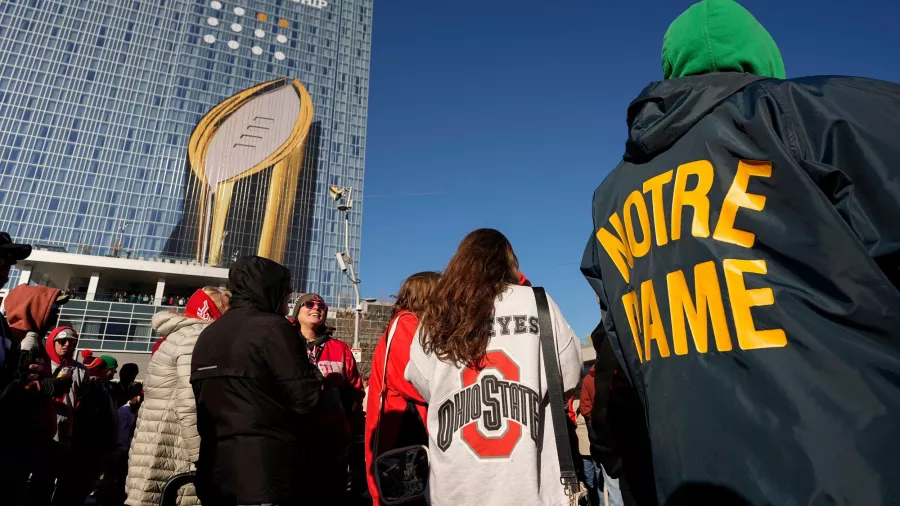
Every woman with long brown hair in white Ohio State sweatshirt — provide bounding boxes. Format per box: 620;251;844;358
406;229;581;506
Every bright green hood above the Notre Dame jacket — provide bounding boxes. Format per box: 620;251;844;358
662;0;786;79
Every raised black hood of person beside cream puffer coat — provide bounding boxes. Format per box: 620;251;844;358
228;256;291;313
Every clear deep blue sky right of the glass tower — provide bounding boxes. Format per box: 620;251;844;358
360;0;900;338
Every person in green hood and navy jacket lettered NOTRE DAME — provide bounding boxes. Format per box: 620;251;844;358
581;0;900;505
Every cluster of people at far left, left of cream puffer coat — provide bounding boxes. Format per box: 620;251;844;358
0;256;141;506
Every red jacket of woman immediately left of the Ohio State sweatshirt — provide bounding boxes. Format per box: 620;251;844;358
366;311;428;504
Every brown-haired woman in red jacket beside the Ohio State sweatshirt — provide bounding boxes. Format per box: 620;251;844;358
366;271;440;504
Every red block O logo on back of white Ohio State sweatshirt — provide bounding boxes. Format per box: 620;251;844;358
462;351;522;458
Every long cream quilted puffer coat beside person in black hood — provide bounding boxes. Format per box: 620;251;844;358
125;312;209;506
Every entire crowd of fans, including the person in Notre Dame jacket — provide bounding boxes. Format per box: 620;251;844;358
0;0;900;506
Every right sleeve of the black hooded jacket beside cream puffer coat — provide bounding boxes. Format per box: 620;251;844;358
261;319;322;416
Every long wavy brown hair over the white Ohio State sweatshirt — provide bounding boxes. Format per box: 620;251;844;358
420;228;519;369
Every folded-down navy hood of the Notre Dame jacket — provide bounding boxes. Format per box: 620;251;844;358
624;72;765;163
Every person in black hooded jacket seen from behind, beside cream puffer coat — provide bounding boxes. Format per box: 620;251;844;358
191;256;322;506
